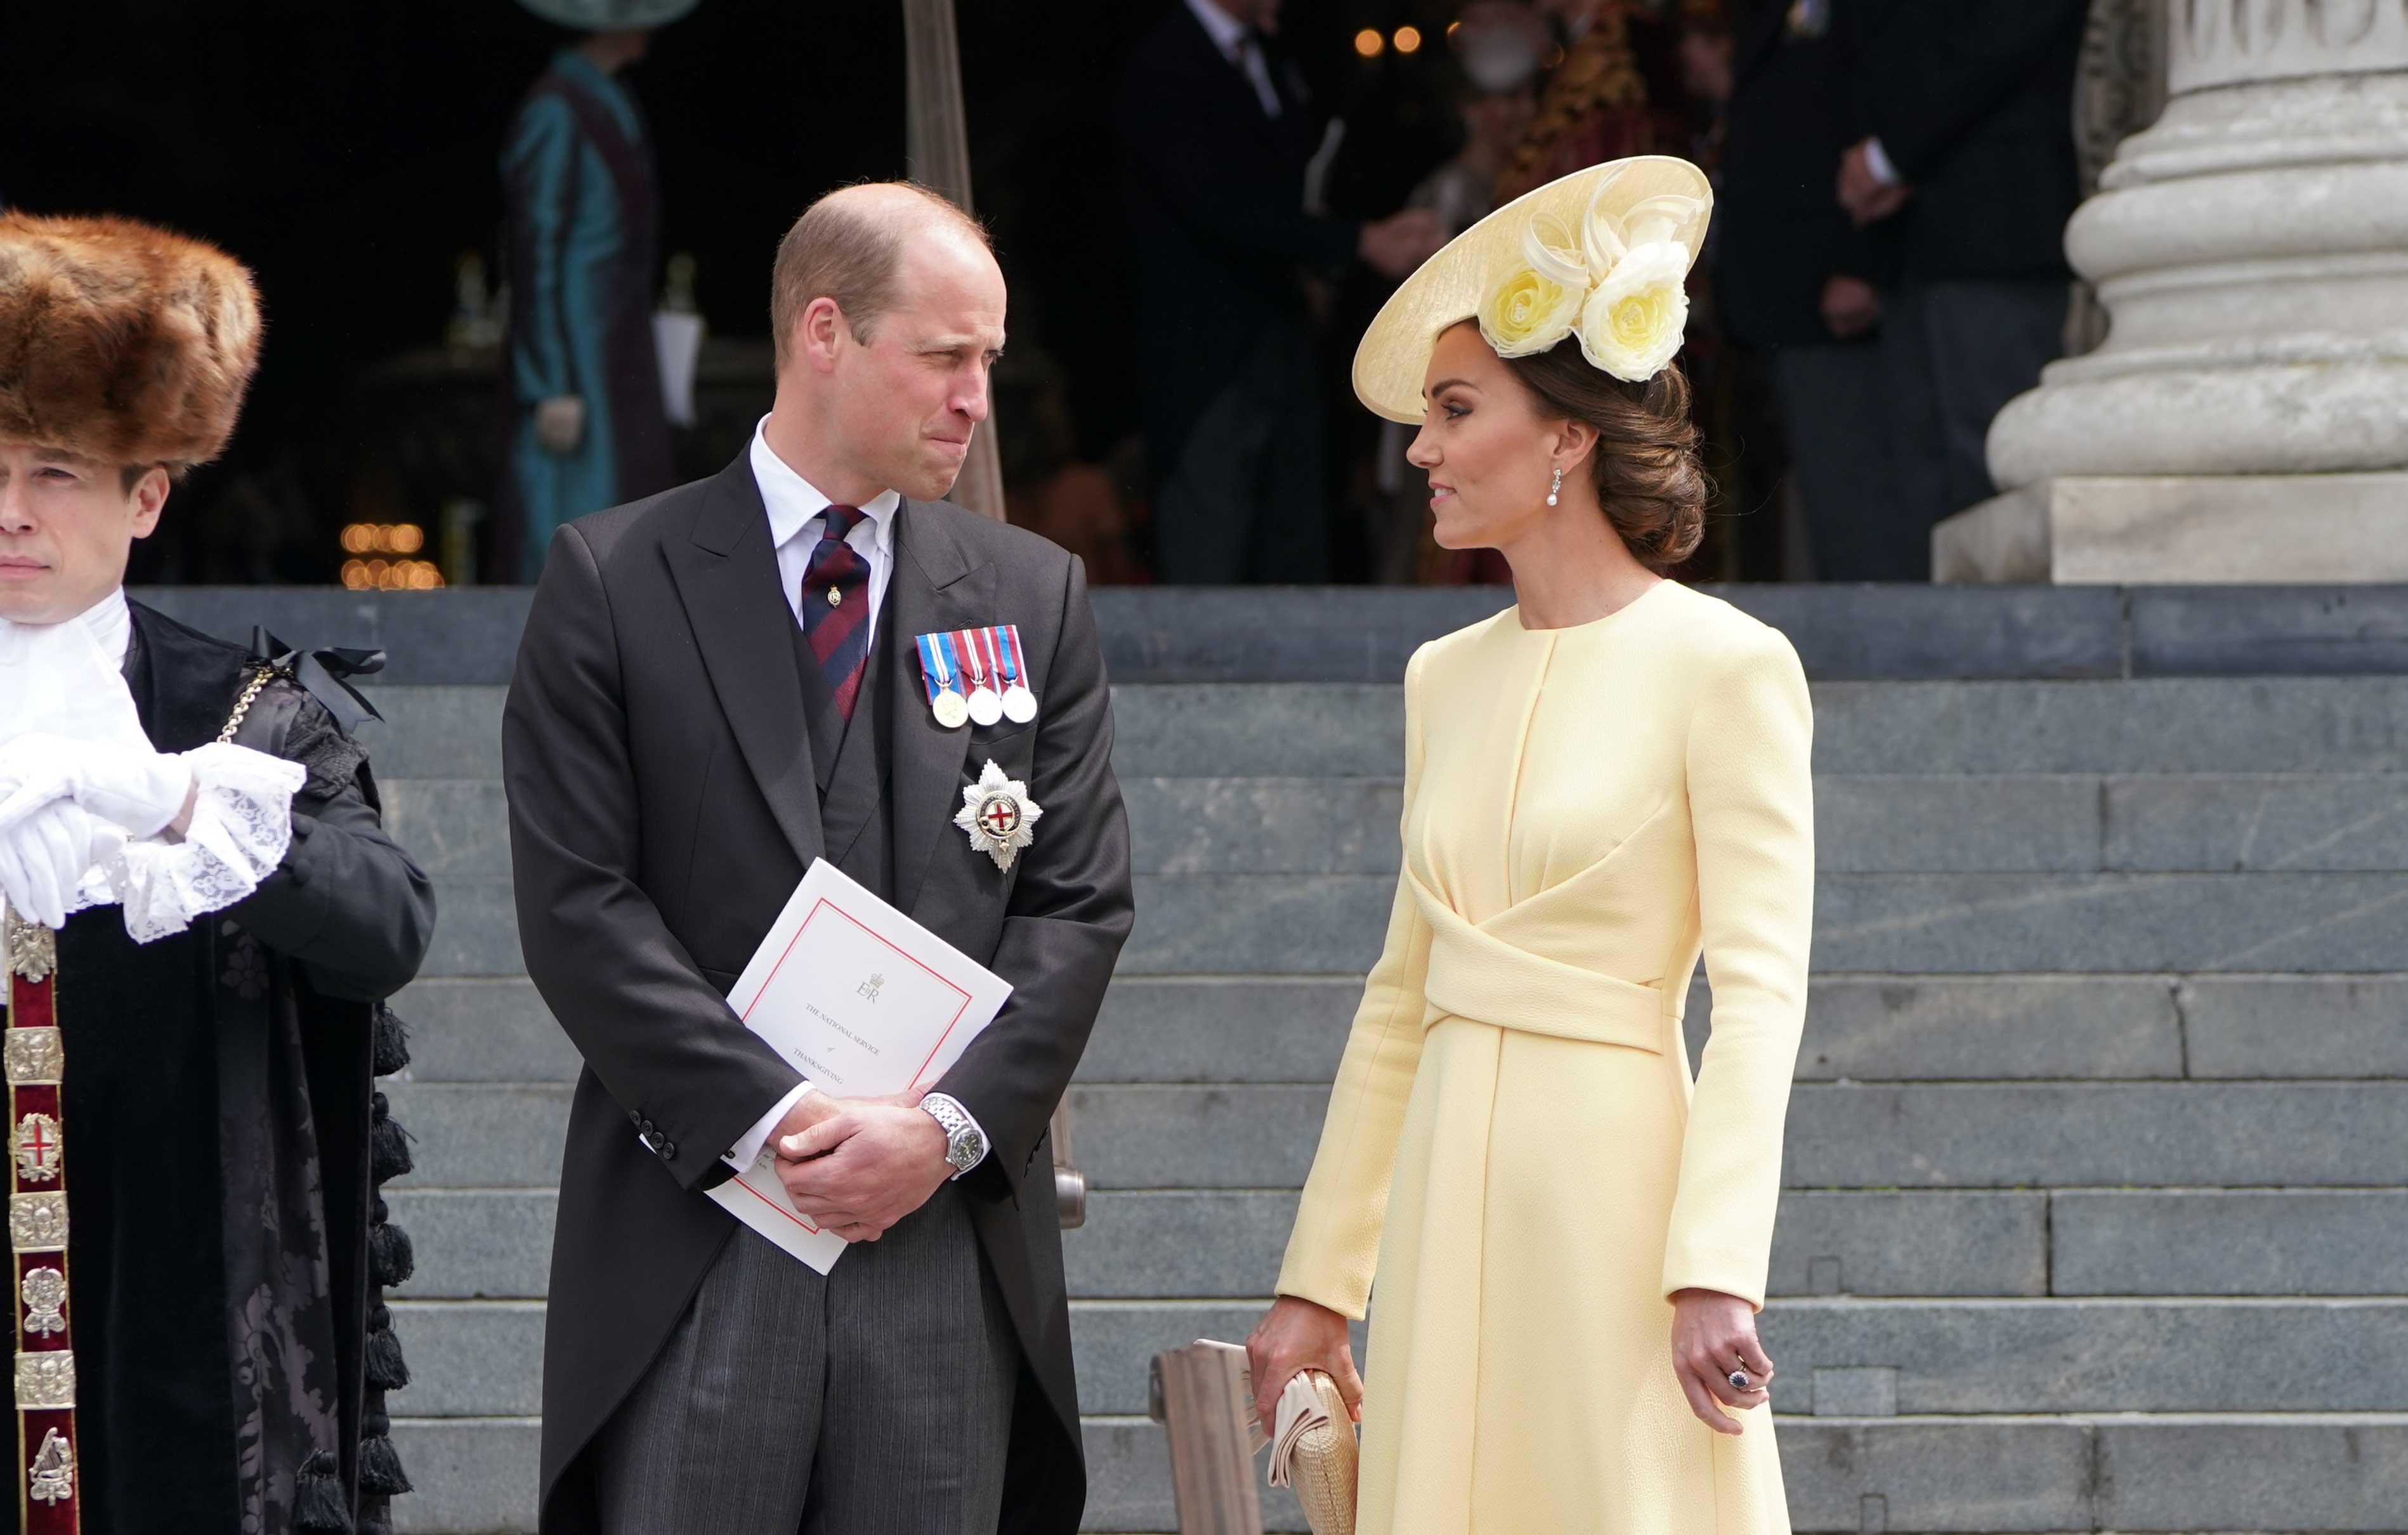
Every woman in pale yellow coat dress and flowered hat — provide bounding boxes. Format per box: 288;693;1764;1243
1250;157;1813;1535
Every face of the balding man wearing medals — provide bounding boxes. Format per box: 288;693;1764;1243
835;228;1004;500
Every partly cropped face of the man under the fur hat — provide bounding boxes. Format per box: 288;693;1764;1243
0;443;169;623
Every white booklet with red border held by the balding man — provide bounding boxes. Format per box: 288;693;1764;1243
710;859;1011;1273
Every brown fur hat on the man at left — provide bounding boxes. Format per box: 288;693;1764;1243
0;214;260;469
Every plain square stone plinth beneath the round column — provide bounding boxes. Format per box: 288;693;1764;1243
1931;471;2408;587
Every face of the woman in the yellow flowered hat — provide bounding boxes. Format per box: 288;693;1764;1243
1404;320;1555;549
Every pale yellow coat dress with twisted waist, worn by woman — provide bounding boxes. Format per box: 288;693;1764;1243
1279;582;1813;1535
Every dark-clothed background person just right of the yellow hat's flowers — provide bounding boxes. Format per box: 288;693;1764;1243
1712;0;1924;580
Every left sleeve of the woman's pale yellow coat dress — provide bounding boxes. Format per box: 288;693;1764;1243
1279;650;1430;1321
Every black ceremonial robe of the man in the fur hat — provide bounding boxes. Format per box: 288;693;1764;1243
0;604;433;1535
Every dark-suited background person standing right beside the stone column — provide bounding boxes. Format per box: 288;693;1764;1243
1833;0;2088;580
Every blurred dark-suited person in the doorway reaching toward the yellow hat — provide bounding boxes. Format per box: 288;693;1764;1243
1120;0;1445;585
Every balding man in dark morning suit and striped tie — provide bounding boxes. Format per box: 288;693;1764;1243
503;185;1132;1535
